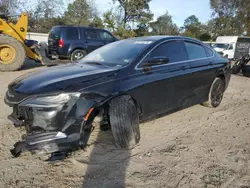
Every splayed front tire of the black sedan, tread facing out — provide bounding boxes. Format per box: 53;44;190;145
109;95;140;149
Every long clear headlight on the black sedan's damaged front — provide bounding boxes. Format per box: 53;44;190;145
20;92;80;108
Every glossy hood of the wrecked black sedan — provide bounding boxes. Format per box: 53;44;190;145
9;64;119;94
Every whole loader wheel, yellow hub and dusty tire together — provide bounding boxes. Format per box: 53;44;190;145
0;35;26;71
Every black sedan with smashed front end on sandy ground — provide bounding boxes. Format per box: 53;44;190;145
5;36;231;159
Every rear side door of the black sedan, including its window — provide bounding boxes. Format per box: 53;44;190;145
185;40;216;104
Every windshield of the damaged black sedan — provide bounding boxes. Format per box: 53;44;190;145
80;39;152;66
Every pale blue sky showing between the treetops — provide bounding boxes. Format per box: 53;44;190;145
95;0;212;27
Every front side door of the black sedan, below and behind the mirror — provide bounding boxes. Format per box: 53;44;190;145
136;40;189;118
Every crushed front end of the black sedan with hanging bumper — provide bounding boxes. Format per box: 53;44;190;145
5;90;94;160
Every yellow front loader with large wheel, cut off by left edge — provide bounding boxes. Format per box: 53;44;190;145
0;13;58;71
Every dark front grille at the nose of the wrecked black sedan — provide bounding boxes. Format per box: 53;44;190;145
5;89;29;104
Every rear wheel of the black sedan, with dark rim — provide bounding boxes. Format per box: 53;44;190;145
202;77;225;108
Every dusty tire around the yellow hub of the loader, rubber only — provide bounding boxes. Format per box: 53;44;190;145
0;35;26;72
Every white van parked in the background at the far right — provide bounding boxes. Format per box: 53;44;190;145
212;36;250;60
